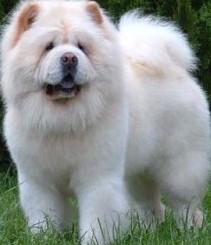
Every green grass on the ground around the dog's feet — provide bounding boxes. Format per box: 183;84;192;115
0;173;211;245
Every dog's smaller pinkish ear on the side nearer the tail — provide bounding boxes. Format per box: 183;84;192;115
86;1;103;24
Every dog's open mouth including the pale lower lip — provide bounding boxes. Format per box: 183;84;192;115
45;74;81;99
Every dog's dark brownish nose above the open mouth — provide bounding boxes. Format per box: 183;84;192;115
60;52;78;72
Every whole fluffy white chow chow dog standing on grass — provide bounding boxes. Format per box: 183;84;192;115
1;0;210;244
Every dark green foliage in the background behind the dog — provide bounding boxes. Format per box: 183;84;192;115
0;0;211;170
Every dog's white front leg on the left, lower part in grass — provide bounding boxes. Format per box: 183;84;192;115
19;173;70;233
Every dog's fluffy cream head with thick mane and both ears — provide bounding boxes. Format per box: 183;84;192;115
1;0;121;133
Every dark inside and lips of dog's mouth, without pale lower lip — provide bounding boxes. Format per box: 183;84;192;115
45;74;81;96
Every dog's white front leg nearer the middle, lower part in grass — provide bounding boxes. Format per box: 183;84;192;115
77;176;129;245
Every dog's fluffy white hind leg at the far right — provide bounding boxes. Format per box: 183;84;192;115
162;152;209;227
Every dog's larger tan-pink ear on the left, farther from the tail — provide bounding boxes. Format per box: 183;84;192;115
13;2;39;45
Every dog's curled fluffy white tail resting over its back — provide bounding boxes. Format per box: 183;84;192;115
119;11;196;71
